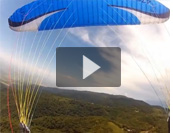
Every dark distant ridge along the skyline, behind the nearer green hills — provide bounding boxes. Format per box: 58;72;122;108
42;87;151;111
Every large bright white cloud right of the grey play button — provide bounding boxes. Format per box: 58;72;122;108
68;24;170;106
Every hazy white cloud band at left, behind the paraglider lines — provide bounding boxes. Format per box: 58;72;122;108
0;46;56;87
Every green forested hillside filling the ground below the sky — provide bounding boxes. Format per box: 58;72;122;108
0;86;168;133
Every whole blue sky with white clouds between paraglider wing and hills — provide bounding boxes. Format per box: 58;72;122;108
0;0;171;105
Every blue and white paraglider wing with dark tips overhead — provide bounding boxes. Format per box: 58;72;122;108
9;0;170;31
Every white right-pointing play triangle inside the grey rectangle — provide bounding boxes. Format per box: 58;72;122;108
83;55;100;79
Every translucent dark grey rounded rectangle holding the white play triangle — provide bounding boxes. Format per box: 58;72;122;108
56;47;121;87
